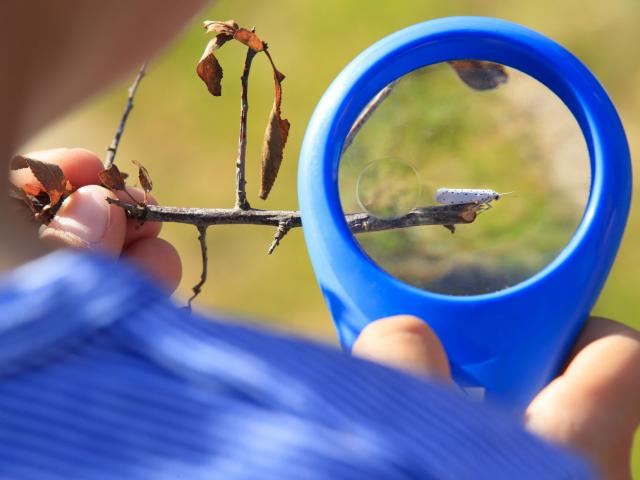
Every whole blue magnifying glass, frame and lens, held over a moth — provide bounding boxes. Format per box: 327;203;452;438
298;17;631;411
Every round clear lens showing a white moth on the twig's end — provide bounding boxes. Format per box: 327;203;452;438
339;60;590;295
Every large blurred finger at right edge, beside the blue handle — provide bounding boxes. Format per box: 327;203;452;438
525;317;640;478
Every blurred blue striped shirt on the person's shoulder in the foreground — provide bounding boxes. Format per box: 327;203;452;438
0;252;591;480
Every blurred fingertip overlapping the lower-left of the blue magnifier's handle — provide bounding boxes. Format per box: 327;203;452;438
352;315;451;383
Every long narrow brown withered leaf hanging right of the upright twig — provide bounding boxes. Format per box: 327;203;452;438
260;50;290;200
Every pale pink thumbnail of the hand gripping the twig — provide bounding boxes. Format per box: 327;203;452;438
40;186;110;248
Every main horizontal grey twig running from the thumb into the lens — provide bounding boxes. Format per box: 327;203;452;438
107;198;482;233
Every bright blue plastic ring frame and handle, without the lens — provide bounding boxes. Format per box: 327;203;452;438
298;17;631;410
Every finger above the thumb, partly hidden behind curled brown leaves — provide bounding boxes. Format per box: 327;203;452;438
10;148;102;188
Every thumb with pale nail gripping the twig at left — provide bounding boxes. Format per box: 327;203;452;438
40;185;126;256
